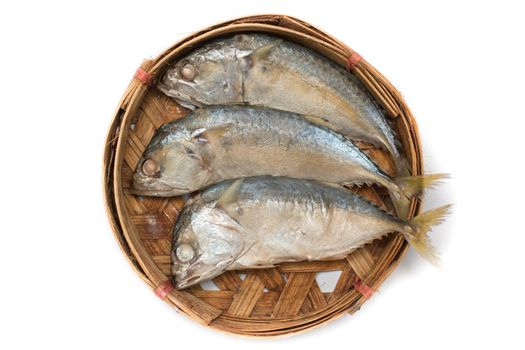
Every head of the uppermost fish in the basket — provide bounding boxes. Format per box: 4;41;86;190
157;40;242;110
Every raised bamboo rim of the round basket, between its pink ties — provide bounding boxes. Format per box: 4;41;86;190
103;15;423;337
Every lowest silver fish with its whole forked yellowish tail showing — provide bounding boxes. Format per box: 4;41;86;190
171;176;450;289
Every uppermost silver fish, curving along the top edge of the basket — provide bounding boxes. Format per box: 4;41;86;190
157;33;404;176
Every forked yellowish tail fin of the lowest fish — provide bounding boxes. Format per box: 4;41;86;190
403;204;452;266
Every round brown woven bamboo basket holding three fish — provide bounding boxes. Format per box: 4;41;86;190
103;15;423;337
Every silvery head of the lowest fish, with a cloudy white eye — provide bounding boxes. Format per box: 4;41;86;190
171;205;247;289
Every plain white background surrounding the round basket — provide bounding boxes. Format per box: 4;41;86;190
0;0;525;349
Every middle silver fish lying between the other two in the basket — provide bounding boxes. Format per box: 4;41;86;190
132;105;443;212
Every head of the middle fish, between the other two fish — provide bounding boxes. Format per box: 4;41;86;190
131;123;212;197
